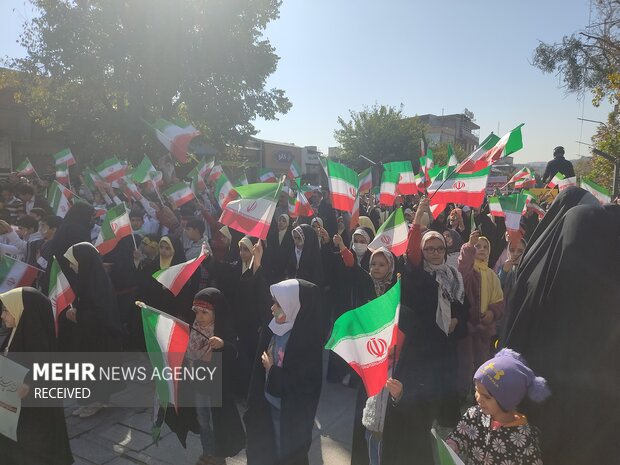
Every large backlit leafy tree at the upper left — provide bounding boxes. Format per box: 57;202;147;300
0;0;291;163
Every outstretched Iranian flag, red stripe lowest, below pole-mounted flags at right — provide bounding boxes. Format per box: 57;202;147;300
428;167;491;208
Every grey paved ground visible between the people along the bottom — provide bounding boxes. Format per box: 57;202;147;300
65;368;355;465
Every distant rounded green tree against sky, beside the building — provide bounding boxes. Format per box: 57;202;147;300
334;104;424;170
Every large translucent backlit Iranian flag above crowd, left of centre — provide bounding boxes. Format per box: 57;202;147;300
220;183;282;240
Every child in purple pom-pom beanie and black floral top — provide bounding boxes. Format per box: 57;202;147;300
446;349;550;465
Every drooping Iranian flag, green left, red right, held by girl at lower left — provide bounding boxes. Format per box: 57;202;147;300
136;302;189;409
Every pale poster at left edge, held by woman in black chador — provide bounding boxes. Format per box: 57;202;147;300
0;356;28;441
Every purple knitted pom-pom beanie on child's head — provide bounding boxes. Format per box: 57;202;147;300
474;349;551;412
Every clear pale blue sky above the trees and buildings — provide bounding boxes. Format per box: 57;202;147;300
0;0;609;162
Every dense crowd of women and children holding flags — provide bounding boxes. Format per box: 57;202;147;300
0;165;620;465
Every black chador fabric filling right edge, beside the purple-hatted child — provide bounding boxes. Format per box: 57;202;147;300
504;202;620;465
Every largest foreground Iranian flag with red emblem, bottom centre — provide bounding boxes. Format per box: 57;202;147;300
325;281;400;397
